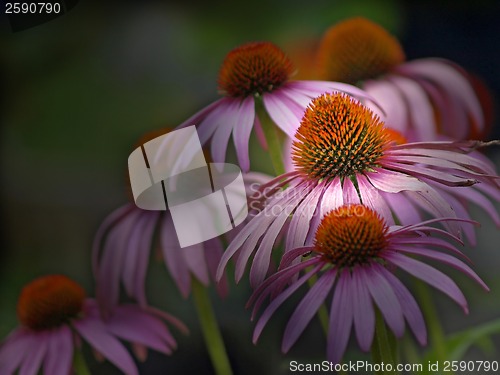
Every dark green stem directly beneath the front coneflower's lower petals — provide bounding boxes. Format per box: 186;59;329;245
371;309;397;374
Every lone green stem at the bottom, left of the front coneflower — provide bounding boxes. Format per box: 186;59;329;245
193;278;233;375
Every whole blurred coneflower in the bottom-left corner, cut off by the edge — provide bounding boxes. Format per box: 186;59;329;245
0;275;186;375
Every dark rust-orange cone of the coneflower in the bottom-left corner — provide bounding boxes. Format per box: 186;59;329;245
17;275;85;331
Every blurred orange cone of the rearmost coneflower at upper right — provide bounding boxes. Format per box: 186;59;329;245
317;17;405;84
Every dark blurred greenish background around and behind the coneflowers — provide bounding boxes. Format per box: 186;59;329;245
0;0;500;374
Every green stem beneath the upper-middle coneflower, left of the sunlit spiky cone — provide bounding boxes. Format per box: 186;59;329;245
255;96;285;176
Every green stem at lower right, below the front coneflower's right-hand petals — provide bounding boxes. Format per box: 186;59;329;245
416;280;448;363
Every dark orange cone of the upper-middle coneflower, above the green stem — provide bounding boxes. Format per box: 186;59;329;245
218;42;294;97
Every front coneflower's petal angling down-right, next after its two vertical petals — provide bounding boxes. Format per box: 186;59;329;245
360;262;405;337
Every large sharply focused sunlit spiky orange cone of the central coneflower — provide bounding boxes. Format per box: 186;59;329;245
292;93;394;179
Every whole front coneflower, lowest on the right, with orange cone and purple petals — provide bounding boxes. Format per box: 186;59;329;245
248;205;488;363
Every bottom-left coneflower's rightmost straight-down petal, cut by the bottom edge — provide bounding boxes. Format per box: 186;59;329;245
43;326;73;375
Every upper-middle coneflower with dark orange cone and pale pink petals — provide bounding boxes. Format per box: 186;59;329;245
174;42;374;172
